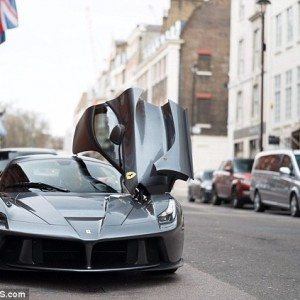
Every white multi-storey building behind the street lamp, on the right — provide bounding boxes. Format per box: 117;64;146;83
228;0;300;157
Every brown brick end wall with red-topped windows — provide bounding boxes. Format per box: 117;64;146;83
179;0;230;136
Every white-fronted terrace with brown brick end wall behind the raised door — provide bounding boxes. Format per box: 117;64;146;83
73;0;230;170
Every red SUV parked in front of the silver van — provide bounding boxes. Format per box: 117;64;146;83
211;158;253;208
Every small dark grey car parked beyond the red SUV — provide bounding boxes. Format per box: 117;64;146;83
188;170;214;203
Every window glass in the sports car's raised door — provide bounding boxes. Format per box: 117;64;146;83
94;107;119;163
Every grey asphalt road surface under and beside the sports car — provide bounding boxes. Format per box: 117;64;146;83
0;192;300;300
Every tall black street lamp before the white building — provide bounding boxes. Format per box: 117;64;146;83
256;0;271;151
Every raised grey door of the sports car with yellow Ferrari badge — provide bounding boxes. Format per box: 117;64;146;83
73;89;193;195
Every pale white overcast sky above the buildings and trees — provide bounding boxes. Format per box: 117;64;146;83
0;0;169;136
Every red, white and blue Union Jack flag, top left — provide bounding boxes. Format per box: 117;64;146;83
0;0;18;32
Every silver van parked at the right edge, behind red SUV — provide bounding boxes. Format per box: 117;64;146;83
250;150;300;217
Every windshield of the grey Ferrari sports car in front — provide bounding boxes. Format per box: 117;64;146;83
0;158;121;193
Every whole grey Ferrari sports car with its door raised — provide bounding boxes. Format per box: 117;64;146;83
0;89;193;272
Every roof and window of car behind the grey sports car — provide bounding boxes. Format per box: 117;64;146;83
0;147;57;172
